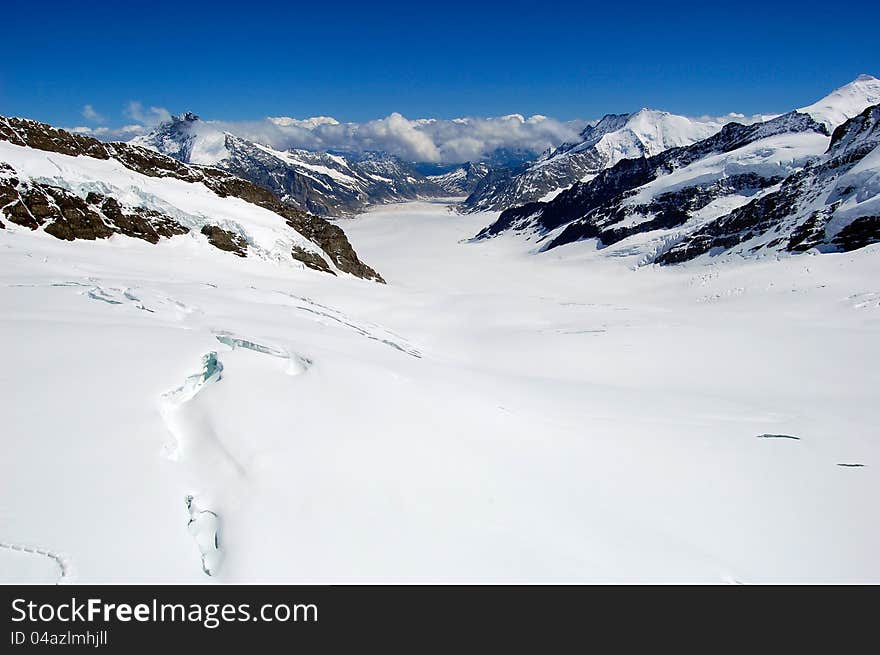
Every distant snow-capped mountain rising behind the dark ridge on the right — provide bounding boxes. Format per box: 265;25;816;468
462;109;740;212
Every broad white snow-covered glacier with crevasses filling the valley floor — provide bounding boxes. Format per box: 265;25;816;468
0;204;880;583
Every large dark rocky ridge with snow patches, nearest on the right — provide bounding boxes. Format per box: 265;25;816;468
477;76;880;264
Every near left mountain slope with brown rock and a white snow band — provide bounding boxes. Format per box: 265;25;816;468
0;117;381;281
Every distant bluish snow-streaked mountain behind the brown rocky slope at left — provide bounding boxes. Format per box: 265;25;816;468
133;113;442;216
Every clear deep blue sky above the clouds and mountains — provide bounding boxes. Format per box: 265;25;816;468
0;0;880;126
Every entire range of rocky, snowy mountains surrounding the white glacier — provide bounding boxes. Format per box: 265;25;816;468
0;75;880;280
